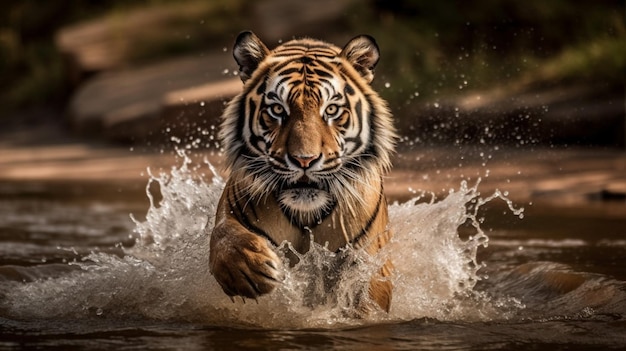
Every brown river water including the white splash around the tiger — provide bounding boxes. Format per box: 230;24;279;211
0;153;626;350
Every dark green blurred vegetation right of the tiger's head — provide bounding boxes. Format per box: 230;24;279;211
349;0;626;106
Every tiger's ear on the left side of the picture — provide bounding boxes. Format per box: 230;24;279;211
233;31;270;82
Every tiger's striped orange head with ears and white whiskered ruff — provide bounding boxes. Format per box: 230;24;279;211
220;32;396;225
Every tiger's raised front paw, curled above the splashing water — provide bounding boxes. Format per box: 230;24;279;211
209;228;283;299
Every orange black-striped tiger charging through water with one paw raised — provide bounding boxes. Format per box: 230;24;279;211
209;31;397;312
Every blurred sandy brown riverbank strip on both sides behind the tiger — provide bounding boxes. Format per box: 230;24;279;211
0;109;626;207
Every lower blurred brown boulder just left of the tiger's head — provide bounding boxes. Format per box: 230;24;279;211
68;52;235;139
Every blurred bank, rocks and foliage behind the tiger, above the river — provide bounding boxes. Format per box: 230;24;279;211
0;0;626;202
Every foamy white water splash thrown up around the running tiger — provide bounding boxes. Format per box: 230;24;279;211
0;152;521;328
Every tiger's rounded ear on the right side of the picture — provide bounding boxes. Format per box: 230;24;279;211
339;35;380;83
